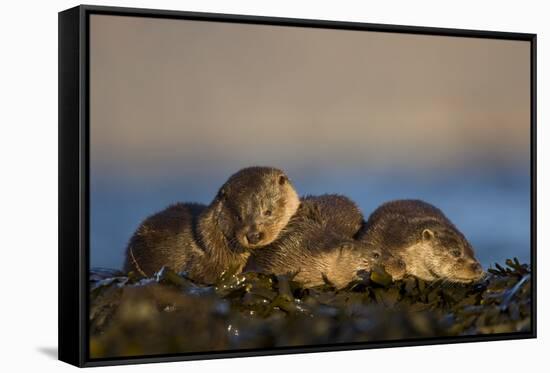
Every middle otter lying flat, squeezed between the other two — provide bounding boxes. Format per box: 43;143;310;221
244;195;405;289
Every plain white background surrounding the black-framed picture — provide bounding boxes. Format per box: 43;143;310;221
0;0;550;373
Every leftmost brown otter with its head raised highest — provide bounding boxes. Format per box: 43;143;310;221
125;167;300;283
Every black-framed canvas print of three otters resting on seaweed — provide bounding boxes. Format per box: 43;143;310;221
59;6;536;366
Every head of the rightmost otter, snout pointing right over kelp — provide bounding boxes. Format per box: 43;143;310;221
405;225;483;283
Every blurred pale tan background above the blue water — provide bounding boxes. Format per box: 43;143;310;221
90;15;530;178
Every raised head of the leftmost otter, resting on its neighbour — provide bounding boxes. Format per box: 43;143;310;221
215;167;300;249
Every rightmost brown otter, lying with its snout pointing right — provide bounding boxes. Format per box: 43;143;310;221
357;200;483;283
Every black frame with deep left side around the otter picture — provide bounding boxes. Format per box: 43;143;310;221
58;5;537;367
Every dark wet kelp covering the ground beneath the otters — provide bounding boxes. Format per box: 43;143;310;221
89;259;531;358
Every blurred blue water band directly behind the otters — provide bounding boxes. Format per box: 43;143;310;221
90;167;530;268
